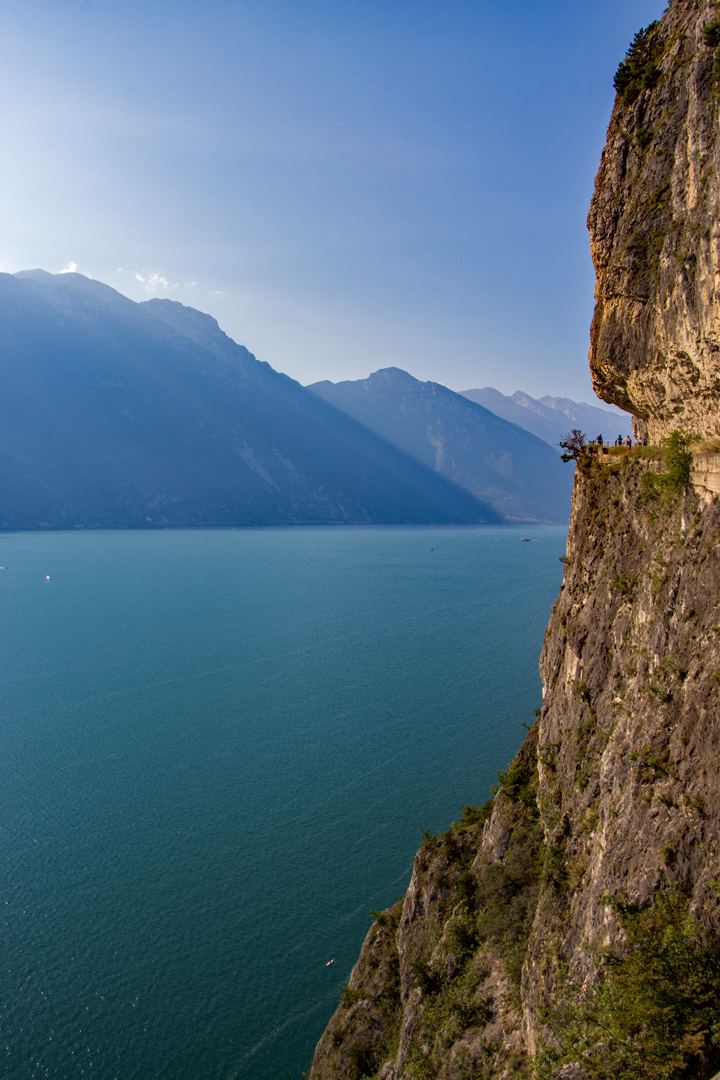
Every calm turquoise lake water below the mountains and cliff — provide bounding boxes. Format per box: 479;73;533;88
0;527;566;1080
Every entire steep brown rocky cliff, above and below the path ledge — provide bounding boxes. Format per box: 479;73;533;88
310;0;720;1080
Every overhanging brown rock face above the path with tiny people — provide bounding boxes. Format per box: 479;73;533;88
588;0;720;442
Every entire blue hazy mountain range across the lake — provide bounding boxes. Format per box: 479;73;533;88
0;270;616;529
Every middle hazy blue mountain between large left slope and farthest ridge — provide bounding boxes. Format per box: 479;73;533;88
308;367;572;523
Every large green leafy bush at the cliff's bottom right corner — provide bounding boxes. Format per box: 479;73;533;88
535;888;720;1080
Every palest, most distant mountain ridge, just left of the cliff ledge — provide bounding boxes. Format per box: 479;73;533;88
461;387;631;448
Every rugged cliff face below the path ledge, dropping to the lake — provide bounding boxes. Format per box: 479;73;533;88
310;455;720;1080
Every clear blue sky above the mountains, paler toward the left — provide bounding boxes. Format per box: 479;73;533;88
0;0;665;404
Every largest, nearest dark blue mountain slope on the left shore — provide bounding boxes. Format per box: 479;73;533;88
0;271;498;528
